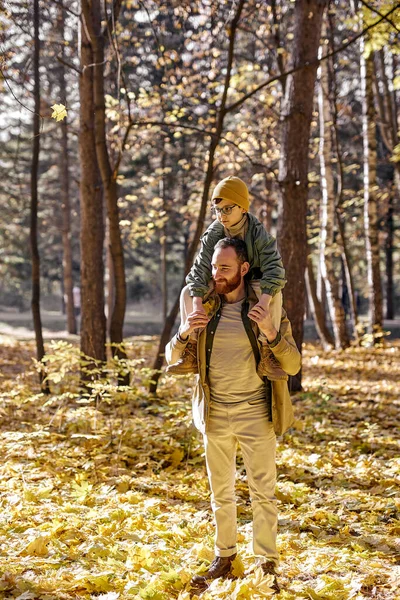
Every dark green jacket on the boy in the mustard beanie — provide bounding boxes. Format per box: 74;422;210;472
186;213;286;298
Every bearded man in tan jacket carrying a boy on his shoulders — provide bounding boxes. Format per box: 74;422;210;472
166;238;300;591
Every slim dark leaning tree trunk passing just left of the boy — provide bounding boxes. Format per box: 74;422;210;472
149;0;244;394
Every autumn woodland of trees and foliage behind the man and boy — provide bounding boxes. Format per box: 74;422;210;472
0;0;400;384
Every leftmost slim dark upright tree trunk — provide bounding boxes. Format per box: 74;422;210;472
30;0;49;392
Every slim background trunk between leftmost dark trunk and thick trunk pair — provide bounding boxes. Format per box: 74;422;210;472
58;0;77;333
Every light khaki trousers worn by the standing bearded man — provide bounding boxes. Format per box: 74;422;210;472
204;400;278;565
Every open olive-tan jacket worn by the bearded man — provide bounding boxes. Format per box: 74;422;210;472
165;286;301;435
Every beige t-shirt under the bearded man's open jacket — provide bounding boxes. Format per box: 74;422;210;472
208;300;265;403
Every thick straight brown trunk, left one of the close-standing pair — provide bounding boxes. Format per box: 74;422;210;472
79;2;106;362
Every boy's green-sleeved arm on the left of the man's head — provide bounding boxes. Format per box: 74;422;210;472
186;222;223;298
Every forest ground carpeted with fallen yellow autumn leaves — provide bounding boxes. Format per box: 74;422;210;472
0;337;400;600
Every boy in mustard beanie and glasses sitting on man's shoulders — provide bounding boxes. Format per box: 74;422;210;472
167;176;287;381
